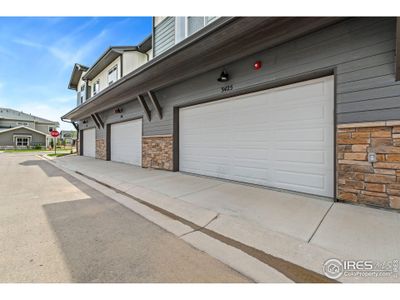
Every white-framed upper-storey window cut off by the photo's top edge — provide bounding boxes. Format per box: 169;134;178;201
175;17;217;43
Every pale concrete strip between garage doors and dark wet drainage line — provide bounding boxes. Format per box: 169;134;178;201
48;156;400;282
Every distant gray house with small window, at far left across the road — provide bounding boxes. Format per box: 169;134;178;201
0;108;60;149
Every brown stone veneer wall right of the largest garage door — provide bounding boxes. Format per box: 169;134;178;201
337;121;400;209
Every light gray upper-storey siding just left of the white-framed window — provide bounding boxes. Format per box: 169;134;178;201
154;17;175;56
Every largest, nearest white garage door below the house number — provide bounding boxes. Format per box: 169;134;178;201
179;76;334;197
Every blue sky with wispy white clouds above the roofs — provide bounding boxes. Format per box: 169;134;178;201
0;17;151;129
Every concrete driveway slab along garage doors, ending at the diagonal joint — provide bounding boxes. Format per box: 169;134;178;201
55;156;333;241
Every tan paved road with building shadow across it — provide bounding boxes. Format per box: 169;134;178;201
0;153;249;282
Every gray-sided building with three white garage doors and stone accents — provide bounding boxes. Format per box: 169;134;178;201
63;17;400;209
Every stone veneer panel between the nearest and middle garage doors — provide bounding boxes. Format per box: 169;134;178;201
142;135;173;171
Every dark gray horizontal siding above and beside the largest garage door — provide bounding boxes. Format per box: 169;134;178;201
144;18;400;135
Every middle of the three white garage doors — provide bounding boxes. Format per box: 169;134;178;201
111;119;142;166
